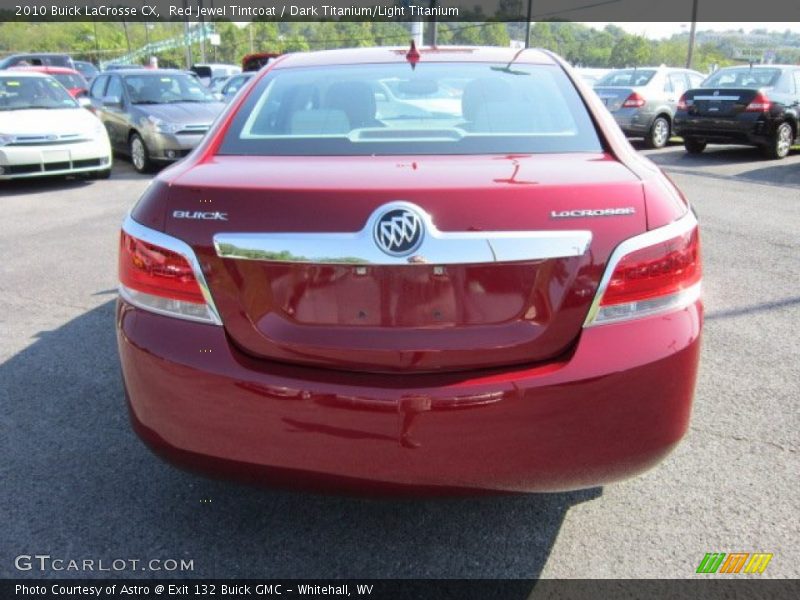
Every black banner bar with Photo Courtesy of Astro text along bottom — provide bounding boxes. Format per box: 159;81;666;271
0;576;800;600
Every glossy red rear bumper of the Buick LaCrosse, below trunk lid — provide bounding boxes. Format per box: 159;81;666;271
117;301;702;493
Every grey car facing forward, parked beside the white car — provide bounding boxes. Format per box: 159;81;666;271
89;69;225;173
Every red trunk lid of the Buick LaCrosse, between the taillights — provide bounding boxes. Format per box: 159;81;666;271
166;154;646;372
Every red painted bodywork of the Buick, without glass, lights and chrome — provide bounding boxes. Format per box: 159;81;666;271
117;48;702;492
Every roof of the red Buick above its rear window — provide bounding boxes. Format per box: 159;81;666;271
274;46;556;69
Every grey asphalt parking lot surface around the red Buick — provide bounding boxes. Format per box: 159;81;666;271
0;145;800;578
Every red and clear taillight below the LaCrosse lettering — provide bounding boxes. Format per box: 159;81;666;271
586;213;702;325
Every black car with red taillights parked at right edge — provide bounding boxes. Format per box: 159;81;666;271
674;65;800;158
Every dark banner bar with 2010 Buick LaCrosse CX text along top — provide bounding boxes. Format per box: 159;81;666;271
0;0;800;23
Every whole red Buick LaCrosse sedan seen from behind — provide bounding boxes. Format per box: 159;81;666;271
117;45;702;493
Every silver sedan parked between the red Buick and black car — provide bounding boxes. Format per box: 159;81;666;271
594;66;705;148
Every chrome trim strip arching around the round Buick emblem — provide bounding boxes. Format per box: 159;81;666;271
214;202;592;265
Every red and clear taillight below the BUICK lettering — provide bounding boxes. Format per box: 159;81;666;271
119;217;219;324
